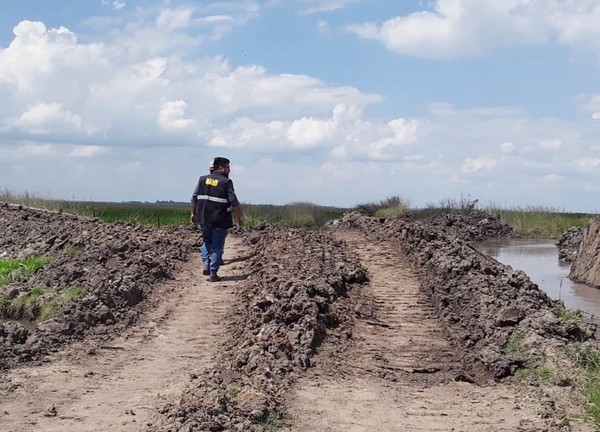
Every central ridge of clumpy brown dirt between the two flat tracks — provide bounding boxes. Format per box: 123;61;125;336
150;227;366;431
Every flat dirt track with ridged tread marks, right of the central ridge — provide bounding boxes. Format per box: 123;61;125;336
286;230;548;432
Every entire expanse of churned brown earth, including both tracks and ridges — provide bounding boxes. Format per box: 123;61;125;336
0;204;598;432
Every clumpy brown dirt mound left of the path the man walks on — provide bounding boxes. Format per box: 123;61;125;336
0;205;198;368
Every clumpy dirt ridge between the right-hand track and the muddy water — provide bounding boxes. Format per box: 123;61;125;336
339;213;593;381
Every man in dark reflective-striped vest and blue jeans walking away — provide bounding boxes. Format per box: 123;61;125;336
190;157;244;282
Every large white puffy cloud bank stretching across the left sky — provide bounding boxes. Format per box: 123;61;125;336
0;16;381;149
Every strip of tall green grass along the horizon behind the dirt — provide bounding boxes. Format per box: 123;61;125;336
0;190;594;235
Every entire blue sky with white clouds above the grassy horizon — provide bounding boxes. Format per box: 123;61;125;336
0;0;600;212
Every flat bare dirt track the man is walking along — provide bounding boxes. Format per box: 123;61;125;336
0;236;244;432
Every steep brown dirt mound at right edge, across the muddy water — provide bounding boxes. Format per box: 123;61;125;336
569;218;600;288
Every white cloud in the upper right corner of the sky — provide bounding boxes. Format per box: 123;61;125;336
347;0;600;58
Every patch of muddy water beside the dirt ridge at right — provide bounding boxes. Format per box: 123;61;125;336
476;239;600;322
